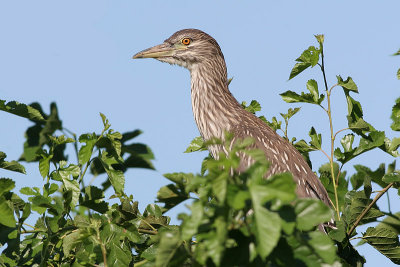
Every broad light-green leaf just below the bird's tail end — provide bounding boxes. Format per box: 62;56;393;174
295;198;332;231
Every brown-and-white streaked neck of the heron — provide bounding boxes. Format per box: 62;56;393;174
190;57;243;140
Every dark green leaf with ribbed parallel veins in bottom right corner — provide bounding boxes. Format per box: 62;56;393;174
362;227;400;264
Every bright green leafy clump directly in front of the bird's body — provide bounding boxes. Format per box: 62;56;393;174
155;138;339;266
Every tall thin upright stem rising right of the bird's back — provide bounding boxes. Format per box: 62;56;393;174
320;44;340;221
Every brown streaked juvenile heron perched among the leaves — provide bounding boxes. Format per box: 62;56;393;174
133;29;330;222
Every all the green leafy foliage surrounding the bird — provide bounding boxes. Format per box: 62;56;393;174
0;35;400;267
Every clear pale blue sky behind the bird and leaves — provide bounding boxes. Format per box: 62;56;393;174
0;0;400;266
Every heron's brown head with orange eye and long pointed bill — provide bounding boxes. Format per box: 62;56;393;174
133;29;224;70
